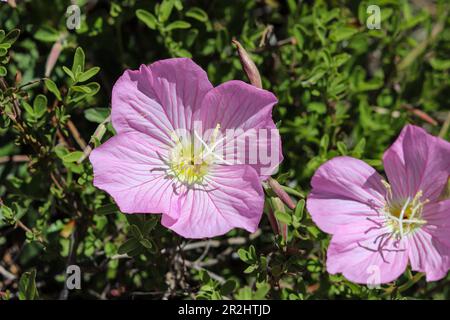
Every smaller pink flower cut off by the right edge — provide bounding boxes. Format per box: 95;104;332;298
307;125;450;285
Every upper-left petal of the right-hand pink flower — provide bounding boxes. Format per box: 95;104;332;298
307;157;385;234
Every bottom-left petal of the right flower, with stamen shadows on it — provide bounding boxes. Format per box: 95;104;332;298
327;218;408;286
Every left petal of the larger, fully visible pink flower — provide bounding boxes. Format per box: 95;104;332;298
89;132;179;217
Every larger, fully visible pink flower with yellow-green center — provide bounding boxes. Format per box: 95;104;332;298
90;59;282;238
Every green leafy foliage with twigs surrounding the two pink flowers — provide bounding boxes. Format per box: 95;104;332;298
0;0;450;299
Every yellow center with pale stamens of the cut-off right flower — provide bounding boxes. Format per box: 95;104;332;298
383;182;428;238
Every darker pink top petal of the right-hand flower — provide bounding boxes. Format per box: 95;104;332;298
383;125;450;200
